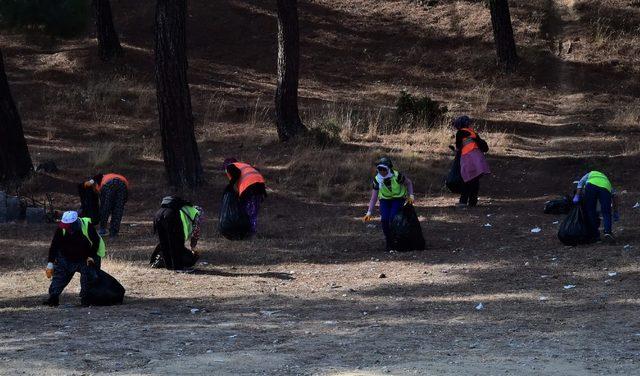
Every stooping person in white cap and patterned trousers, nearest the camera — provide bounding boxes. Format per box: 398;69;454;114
43;211;105;307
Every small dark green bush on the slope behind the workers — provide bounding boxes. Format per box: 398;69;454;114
396;91;449;128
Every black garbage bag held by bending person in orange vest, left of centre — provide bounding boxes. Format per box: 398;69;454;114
218;185;251;240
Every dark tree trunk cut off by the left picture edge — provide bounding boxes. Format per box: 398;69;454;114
0;51;33;182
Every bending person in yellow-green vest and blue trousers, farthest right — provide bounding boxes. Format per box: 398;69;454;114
573;171;620;243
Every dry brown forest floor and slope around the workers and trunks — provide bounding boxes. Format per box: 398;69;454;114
0;0;640;375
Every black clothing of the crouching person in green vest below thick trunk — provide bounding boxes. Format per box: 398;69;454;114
151;208;198;270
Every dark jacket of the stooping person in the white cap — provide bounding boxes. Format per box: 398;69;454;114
48;224;100;262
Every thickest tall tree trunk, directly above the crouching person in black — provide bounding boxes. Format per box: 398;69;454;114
155;0;203;188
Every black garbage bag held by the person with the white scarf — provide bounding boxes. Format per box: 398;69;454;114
389;205;425;252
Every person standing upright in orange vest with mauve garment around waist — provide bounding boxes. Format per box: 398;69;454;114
453;116;491;207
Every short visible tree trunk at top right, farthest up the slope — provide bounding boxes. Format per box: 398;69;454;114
489;0;518;71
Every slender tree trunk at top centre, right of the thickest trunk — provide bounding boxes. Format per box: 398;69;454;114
276;0;305;141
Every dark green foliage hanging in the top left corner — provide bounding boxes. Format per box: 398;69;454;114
0;0;90;38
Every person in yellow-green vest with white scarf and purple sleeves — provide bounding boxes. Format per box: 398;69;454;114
364;157;414;251
